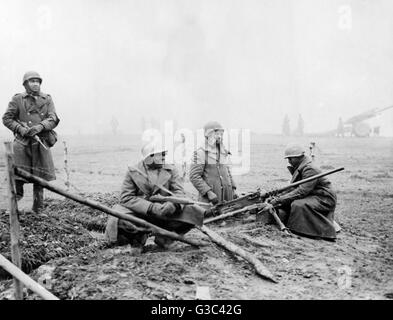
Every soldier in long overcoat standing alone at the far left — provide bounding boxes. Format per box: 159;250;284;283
3;71;60;213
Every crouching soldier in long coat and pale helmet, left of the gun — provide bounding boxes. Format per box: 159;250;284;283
105;144;205;251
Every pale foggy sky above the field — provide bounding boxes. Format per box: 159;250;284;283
0;0;393;135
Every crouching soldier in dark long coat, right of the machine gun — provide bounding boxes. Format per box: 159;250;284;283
264;145;340;240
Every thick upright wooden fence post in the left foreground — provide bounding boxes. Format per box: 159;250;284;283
4;142;23;300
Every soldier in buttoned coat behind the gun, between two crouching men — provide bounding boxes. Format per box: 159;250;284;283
190;121;237;208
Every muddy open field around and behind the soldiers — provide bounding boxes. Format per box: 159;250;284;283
0;136;393;299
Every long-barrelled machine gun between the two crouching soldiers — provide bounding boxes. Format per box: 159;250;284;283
204;167;344;225
